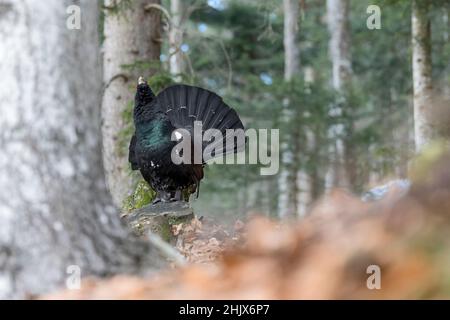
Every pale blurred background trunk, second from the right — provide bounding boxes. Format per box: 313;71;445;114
326;0;355;189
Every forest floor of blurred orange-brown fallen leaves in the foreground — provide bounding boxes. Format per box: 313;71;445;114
49;148;450;299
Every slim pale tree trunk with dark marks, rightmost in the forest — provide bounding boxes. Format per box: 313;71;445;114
412;0;433;151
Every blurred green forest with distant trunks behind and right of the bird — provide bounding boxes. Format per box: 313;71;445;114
105;0;450;217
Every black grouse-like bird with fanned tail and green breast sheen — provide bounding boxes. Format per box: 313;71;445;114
129;77;245;203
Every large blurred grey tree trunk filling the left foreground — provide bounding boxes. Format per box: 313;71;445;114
0;0;161;298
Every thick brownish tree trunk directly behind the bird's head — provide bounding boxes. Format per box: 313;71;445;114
102;0;161;207
